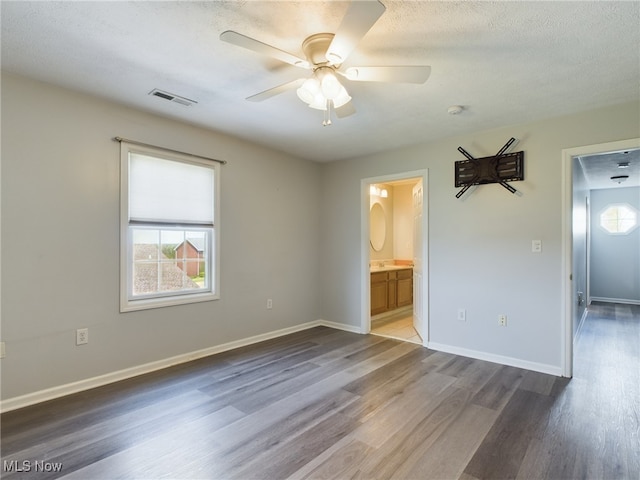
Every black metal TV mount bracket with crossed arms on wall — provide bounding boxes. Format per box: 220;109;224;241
455;137;524;198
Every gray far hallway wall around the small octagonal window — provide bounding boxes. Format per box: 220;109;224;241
591;187;640;304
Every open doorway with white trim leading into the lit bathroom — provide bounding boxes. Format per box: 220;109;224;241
361;170;428;346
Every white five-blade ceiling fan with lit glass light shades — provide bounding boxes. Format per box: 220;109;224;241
220;0;431;126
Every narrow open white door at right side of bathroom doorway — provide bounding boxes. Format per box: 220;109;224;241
413;179;427;342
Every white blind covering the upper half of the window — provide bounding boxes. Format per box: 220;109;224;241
129;152;215;226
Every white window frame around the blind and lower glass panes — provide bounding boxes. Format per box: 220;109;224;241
120;141;221;313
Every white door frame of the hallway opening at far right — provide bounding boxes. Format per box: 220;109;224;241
561;138;640;377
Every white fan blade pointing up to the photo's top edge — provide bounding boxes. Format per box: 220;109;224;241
326;0;385;65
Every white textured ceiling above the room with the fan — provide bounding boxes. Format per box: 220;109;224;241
1;0;640;174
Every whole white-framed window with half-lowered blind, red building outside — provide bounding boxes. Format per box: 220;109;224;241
120;141;219;312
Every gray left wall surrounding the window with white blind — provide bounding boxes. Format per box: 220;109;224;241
1;75;321;398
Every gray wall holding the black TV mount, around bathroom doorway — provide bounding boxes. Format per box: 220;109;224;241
321;103;639;371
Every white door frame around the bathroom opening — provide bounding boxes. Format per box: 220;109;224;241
360;169;429;347
